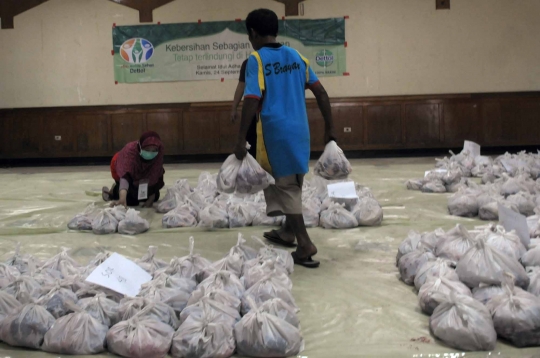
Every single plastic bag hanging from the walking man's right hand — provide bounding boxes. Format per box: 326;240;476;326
314;140;352;180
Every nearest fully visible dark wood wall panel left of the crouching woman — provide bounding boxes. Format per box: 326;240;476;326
76;114;109;157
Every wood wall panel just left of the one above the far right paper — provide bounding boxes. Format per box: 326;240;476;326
404;104;440;148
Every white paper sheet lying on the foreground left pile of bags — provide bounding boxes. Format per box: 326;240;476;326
86;252;152;297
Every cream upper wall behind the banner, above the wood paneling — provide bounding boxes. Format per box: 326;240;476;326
0;0;540;108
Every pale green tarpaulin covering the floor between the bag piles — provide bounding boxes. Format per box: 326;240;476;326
0;158;540;358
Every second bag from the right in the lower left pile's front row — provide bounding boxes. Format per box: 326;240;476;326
171;310;236;358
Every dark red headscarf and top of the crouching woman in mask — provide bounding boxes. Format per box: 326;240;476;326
116;132;165;187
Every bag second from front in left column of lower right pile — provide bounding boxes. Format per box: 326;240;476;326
418;277;472;315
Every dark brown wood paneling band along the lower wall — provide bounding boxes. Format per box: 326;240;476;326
0;92;540;160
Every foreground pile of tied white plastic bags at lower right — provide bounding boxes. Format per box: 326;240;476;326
397;225;540;351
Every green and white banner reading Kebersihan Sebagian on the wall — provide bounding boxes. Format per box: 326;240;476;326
113;18;347;83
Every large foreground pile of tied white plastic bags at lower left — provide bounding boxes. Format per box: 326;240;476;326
0;235;304;358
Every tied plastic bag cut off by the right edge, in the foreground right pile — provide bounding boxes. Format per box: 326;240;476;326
486;275;540;347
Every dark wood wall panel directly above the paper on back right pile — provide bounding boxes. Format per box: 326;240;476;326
441;102;479;146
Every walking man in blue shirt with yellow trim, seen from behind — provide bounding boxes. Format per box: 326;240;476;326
235;9;335;268
